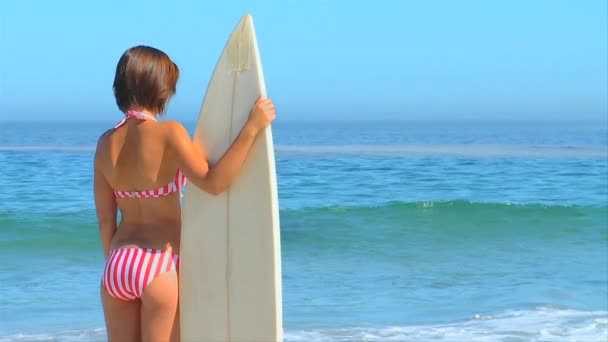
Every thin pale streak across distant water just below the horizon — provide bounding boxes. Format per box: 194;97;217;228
0;144;608;158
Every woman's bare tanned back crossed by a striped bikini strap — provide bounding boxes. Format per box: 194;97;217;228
97;113;183;250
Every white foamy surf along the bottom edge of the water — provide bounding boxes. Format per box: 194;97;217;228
0;307;608;342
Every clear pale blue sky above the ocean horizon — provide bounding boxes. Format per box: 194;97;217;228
0;0;608;122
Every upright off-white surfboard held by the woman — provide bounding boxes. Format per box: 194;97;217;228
180;15;283;342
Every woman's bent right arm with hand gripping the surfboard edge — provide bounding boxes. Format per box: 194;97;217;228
170;98;276;195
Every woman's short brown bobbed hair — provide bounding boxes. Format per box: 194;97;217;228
113;45;179;114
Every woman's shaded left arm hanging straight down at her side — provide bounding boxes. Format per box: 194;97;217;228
93;141;117;259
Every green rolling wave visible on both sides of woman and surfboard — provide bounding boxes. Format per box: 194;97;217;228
0;201;608;250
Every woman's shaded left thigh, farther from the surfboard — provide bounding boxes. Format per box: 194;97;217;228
101;285;141;342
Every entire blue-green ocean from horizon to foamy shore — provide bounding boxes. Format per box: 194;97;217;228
0;116;608;342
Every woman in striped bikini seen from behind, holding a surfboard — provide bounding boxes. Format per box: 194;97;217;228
94;46;275;341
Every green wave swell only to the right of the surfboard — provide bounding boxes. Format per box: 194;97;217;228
281;201;608;253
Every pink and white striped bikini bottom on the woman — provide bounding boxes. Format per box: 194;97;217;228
103;248;179;300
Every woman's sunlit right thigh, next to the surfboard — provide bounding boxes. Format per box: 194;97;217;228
141;272;179;342
